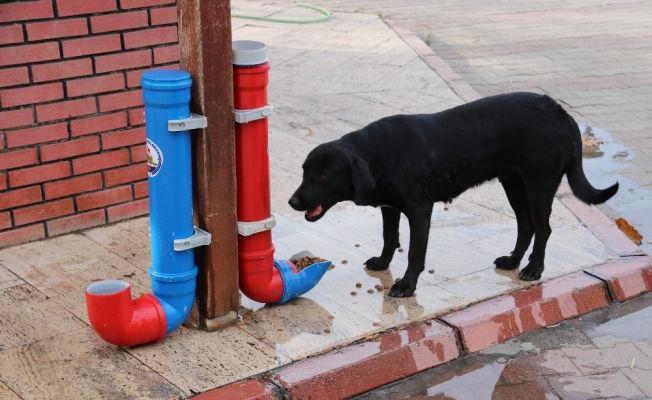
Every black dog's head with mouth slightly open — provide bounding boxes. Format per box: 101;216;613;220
289;141;375;222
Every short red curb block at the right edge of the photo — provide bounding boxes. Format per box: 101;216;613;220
586;257;652;302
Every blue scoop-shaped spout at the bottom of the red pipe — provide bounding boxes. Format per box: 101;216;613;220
274;260;331;304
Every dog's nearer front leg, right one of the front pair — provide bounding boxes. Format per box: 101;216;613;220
389;204;432;297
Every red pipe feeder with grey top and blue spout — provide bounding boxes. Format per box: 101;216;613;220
233;40;331;304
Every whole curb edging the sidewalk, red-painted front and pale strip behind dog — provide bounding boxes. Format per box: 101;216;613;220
195;20;652;400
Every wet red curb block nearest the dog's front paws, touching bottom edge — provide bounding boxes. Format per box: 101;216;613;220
273;322;459;399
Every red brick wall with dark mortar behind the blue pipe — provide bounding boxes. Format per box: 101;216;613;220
0;0;179;247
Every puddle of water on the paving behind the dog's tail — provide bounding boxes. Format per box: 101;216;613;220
580;124;652;254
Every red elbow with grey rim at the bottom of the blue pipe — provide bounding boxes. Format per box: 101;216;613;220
86;280;166;346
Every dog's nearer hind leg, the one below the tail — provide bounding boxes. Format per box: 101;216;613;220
519;175;561;281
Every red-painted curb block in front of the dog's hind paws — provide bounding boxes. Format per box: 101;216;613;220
441;272;609;352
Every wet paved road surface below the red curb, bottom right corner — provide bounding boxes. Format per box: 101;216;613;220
356;294;652;400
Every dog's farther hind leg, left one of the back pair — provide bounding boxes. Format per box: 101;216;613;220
494;174;534;270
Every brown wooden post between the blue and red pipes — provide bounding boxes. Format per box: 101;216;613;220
177;0;240;330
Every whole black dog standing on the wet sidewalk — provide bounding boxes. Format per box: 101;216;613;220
289;93;618;297
